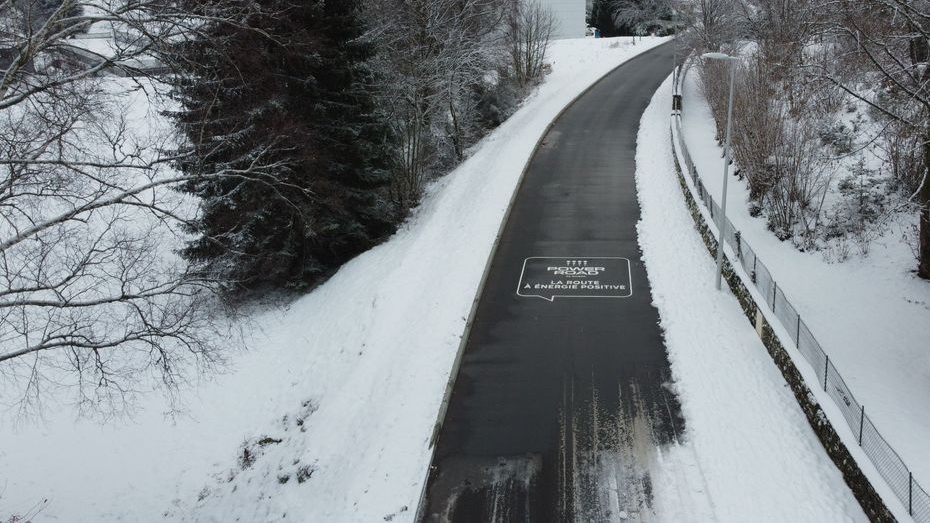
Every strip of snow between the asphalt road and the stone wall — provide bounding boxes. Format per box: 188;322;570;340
636;74;867;522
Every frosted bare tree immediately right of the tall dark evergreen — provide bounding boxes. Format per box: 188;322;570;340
369;0;510;212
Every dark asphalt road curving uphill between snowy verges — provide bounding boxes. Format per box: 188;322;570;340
423;45;683;522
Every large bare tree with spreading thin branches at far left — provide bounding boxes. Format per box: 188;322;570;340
0;0;264;414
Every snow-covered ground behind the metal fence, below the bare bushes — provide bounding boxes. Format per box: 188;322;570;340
682;66;930;485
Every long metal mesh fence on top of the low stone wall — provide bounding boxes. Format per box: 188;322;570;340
673;62;930;523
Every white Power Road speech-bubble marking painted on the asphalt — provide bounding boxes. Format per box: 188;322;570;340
517;256;633;302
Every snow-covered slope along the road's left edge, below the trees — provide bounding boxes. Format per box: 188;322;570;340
0;38;671;523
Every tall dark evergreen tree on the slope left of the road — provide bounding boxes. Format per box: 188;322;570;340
175;0;394;292
